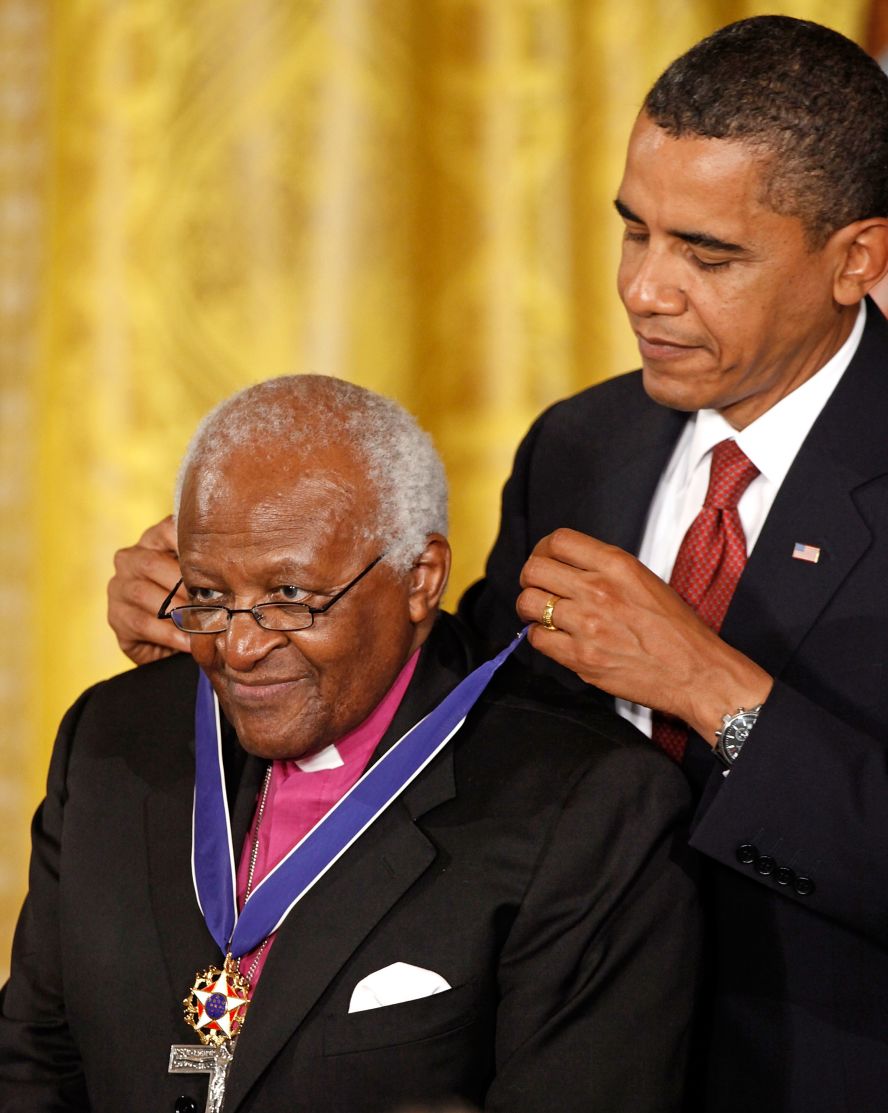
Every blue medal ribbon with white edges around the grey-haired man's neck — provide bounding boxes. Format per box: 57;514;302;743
191;629;526;958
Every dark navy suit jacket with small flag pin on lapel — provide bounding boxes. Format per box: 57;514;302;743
462;304;888;1113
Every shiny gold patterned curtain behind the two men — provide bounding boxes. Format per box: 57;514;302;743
0;0;867;965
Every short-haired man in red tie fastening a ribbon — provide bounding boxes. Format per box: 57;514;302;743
463;17;888;1113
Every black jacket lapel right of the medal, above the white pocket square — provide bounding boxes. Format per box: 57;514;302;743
226;619;466;1113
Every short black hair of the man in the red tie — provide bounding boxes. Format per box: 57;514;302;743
642;16;888;246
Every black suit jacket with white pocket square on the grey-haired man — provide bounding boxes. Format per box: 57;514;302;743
0;619;699;1113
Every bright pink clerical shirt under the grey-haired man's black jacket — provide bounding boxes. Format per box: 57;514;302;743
237;649;420;986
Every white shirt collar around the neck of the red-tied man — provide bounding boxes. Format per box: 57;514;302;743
675;302;867;486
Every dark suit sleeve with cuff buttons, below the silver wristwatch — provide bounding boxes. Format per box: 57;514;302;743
691;682;888;946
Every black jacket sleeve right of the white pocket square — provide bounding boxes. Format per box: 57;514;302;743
485;747;700;1113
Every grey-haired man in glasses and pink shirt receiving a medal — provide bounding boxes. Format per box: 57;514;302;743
0;376;699;1113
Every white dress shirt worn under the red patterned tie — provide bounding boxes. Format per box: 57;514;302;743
616;302;867;737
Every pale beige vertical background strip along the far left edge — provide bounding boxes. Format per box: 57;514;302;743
0;0;46;976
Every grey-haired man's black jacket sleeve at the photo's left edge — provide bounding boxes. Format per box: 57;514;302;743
0;693;89;1113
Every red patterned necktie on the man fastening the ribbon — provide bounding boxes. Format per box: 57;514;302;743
652;441;759;761
